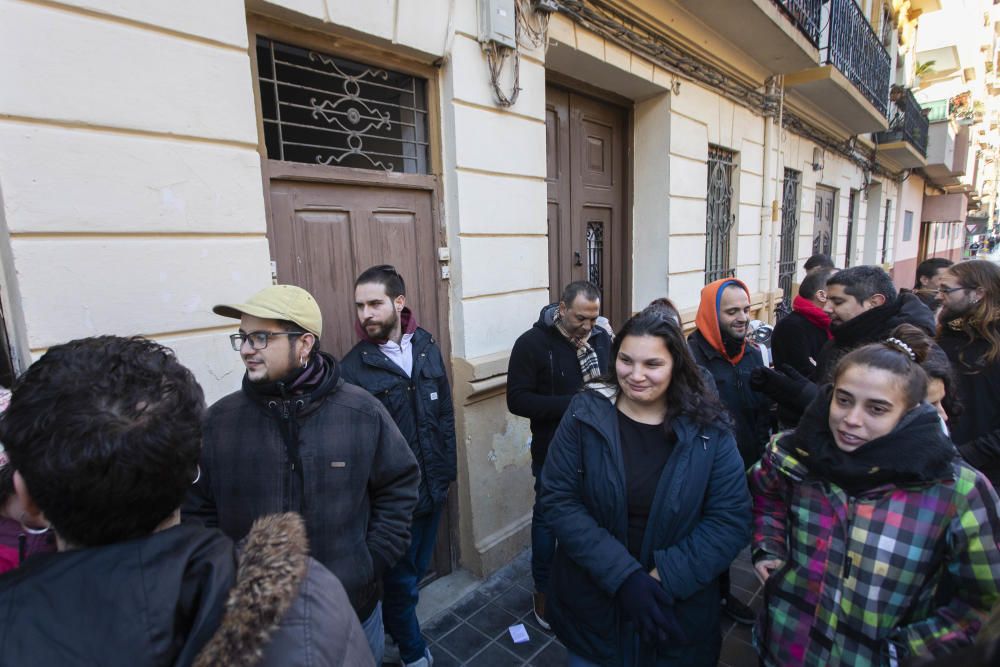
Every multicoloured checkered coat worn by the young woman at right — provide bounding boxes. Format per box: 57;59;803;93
750;436;1000;667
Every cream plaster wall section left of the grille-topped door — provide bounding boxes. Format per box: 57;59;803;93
0;0;270;401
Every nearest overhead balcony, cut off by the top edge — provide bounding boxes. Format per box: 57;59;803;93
678;0;824;74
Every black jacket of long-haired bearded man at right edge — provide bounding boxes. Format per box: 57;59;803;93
938;324;1000;489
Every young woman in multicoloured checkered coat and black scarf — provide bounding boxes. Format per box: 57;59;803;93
750;339;1000;667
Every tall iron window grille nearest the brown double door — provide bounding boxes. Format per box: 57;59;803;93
705;145;736;285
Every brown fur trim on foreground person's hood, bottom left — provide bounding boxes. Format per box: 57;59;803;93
194;513;309;667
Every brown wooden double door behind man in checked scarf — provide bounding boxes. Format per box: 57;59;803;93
545;86;631;327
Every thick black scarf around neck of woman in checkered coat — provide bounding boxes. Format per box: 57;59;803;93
782;385;957;496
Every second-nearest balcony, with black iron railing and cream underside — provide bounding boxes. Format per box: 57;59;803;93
785;0;892;134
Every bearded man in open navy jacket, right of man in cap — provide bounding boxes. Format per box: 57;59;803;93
341;264;455;667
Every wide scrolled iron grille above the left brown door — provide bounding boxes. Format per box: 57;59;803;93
257;37;428;173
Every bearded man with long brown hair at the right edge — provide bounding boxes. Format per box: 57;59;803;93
938;259;1000;488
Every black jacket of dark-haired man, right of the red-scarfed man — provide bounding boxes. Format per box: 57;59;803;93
812;292;934;384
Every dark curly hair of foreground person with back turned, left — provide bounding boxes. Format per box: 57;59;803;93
0;336;205;547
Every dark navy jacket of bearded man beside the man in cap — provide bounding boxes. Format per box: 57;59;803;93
340;327;456;516
